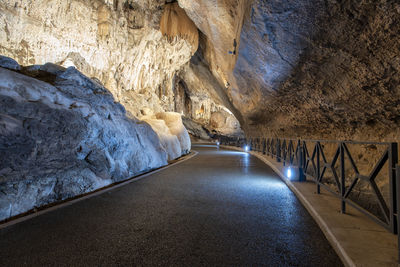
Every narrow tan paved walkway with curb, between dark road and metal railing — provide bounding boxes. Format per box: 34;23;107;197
224;146;400;267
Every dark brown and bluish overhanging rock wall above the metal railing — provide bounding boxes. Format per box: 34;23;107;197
225;0;400;141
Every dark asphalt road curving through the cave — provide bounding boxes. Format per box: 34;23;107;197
0;145;342;266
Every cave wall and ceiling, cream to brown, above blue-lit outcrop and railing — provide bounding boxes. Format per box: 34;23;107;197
0;0;400;140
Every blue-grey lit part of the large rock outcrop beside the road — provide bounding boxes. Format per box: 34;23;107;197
0;66;167;220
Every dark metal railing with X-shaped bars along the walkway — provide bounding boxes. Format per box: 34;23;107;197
216;136;400;259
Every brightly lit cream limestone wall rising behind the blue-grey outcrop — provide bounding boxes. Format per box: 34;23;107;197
0;0;197;118
